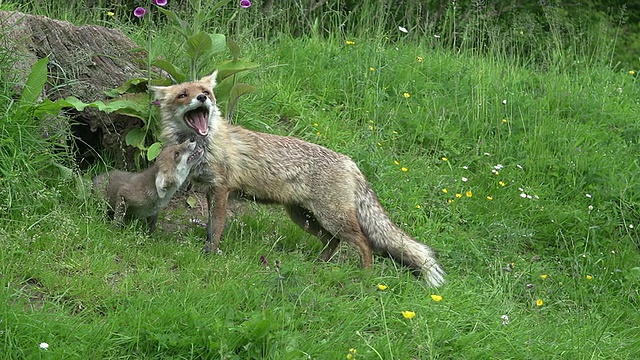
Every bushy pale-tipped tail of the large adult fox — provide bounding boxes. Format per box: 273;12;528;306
356;182;444;287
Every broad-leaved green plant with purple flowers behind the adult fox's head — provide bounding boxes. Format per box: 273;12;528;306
58;0;258;160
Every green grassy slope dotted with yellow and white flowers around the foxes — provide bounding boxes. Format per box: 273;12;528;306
0;1;640;359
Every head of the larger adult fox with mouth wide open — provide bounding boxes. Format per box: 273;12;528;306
151;70;220;139
